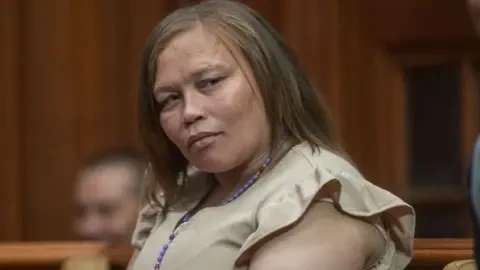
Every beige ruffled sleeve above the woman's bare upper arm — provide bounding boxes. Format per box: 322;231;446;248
240;166;415;269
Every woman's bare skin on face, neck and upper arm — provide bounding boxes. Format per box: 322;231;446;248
130;26;385;270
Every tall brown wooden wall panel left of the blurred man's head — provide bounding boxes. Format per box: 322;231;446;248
21;0;90;240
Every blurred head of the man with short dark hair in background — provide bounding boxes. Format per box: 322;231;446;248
74;148;147;242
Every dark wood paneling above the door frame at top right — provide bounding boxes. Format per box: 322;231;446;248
362;0;479;52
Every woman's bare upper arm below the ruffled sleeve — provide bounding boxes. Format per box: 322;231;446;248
249;203;386;270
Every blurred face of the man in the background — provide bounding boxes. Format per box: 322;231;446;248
74;165;139;241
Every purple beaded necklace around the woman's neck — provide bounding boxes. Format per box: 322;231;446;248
153;157;272;270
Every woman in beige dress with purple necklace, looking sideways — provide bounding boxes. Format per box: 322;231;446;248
130;1;414;270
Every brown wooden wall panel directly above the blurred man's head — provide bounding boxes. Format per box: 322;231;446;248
71;0;136;154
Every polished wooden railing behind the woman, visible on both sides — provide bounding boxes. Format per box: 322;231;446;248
0;239;472;270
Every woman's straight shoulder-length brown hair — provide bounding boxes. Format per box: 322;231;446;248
139;0;342;210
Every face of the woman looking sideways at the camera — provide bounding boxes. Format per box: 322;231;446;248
154;26;270;173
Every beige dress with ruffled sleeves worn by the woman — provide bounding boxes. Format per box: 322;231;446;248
133;144;415;270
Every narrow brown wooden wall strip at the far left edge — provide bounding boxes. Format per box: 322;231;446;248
0;0;22;240
